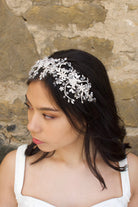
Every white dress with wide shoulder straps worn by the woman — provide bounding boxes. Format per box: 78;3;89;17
14;145;131;207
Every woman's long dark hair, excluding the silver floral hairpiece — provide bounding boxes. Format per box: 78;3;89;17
25;49;130;188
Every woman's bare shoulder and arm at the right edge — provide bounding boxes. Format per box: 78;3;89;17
127;153;138;207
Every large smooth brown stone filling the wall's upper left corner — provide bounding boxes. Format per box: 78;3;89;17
0;0;38;81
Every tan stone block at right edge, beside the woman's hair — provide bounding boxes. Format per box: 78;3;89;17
112;77;138;127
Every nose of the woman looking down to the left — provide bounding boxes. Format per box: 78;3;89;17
27;115;41;133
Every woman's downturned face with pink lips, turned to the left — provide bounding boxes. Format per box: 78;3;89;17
26;81;82;152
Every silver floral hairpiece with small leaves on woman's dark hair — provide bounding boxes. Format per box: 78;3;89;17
29;57;96;104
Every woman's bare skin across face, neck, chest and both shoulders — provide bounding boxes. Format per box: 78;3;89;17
0;81;138;207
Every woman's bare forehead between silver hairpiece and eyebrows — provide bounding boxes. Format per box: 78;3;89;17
27;80;58;108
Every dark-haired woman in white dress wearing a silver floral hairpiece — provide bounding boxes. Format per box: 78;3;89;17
0;49;138;207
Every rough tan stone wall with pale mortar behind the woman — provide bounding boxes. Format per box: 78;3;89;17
0;0;138;162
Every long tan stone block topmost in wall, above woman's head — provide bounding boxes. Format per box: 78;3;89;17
24;3;106;30
